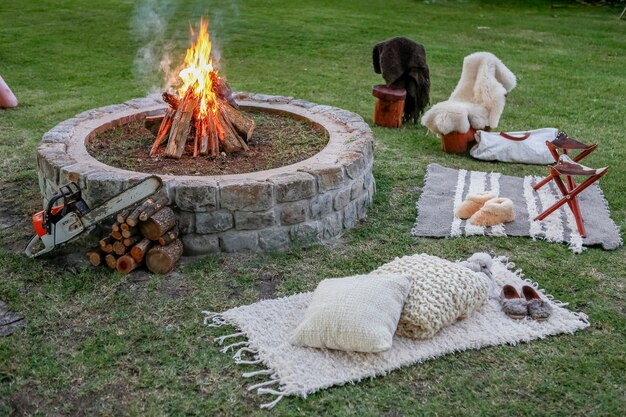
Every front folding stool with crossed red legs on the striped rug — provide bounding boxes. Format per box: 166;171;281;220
535;155;609;237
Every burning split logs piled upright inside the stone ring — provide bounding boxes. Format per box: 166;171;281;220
144;79;256;159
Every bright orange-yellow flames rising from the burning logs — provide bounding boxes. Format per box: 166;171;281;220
178;18;218;117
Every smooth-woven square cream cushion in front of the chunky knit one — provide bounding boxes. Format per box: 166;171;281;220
290;274;411;352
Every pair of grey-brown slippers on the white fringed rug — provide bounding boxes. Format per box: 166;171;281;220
501;285;552;321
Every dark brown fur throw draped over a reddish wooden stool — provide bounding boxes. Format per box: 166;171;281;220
372;37;430;123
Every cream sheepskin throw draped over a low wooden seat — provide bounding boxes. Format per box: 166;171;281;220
422;52;517;135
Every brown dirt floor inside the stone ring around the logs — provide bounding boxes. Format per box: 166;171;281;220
87;111;328;175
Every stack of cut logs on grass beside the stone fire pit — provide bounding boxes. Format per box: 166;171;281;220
87;197;183;274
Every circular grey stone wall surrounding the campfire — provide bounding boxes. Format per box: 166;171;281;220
37;93;375;255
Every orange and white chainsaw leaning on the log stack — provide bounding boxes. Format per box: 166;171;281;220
24;176;162;258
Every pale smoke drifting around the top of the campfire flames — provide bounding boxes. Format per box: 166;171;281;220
130;0;239;93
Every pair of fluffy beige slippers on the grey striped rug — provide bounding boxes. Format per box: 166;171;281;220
454;192;515;226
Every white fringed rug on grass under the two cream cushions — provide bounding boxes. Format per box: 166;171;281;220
204;258;589;408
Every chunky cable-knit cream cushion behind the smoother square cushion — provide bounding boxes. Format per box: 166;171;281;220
372;254;489;339
